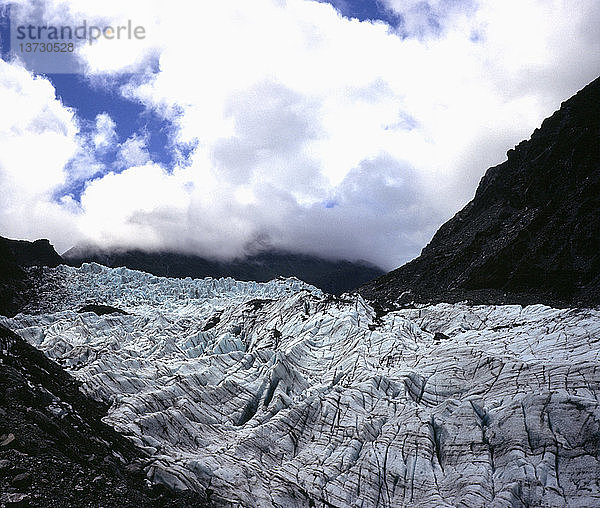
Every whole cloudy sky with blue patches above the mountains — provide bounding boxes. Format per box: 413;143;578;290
0;0;600;269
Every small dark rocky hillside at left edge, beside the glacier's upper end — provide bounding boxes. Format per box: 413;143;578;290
0;236;63;316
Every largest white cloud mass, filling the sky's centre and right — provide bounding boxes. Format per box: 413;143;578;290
1;0;600;268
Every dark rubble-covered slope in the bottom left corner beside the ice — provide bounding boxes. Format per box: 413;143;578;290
0;326;206;508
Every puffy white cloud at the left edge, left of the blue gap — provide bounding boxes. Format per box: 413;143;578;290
0;60;78;246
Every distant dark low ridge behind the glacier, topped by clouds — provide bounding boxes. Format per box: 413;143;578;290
63;247;384;295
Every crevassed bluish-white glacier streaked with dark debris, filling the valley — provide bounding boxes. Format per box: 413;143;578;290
2;264;600;508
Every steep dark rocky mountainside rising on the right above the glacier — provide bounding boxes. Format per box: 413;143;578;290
359;78;600;309
